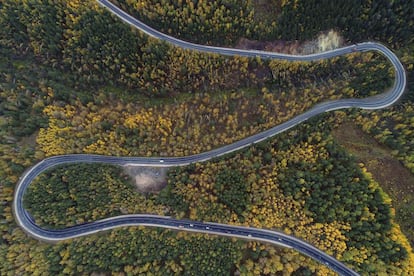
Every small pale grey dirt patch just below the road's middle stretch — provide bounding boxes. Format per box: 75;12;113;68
124;166;168;193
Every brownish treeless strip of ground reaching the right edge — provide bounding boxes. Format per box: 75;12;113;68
332;122;414;245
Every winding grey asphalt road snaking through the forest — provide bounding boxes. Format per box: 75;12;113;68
13;0;406;275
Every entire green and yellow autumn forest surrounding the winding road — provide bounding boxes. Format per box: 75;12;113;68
0;0;414;275
